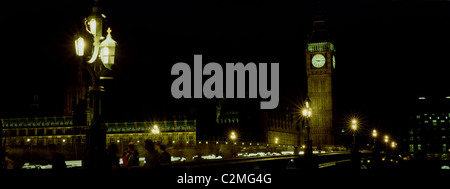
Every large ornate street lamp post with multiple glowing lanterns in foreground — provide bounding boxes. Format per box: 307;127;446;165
75;1;117;168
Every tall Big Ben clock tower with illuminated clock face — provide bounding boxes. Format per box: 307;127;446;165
305;14;335;146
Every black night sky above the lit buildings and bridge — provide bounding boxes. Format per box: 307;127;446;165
0;0;450;139
